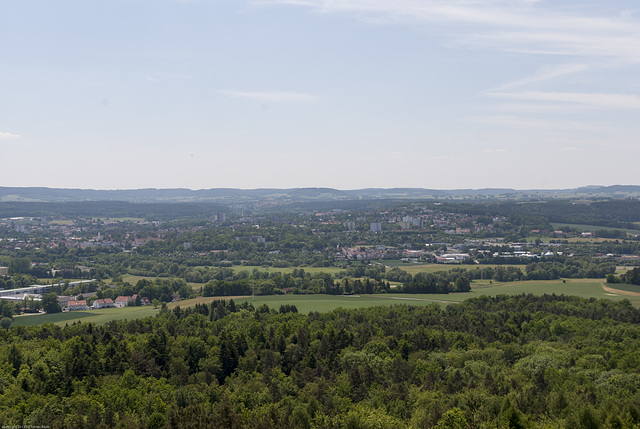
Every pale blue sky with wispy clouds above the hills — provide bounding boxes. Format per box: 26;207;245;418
0;0;640;189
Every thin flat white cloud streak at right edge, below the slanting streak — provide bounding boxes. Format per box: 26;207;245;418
488;91;640;109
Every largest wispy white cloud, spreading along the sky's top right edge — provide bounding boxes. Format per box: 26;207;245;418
254;0;640;62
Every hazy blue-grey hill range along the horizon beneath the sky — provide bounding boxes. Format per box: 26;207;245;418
0;185;640;206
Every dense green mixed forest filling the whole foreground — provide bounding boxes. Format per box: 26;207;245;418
0;295;640;428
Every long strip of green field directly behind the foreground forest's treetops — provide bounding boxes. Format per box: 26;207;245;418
13;279;640;326
